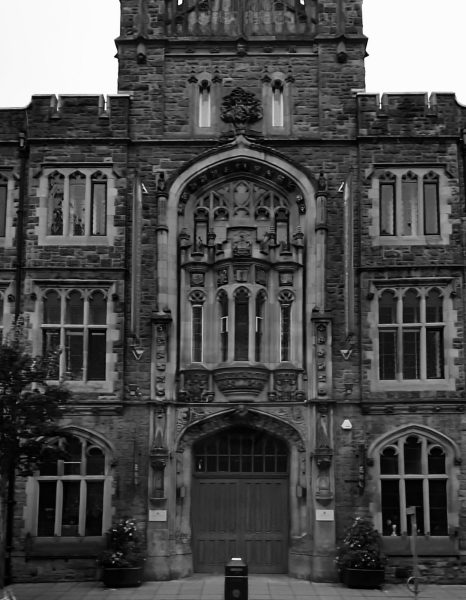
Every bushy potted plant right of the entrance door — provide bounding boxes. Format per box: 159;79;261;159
335;517;386;588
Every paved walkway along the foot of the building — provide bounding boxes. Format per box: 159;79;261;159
11;575;466;600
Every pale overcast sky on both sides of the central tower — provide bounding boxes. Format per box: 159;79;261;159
0;0;466;107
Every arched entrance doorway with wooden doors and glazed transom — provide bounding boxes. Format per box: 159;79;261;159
191;426;289;573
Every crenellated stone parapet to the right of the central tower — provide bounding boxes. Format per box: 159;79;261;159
357;93;466;136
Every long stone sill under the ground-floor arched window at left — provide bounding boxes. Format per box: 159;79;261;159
24;536;106;558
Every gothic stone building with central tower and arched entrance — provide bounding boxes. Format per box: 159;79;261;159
0;0;466;582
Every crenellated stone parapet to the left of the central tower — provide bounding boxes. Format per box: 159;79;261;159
0;94;130;140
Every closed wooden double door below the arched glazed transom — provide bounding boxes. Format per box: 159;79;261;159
192;476;288;573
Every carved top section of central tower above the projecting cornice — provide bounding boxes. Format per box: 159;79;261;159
117;0;362;42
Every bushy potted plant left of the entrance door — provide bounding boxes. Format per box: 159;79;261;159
98;519;145;588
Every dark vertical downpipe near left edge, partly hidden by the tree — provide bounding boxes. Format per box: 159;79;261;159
5;132;29;585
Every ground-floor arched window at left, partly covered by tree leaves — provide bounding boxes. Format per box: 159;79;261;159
33;437;111;537
